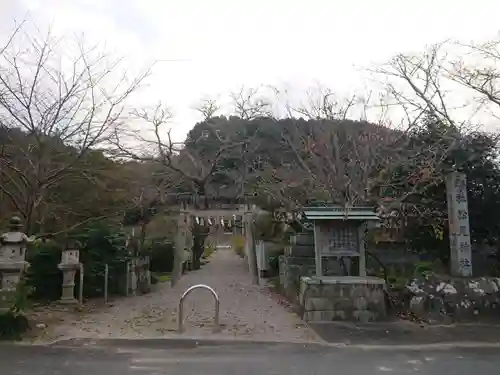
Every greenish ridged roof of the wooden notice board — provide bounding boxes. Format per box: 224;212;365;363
303;206;380;221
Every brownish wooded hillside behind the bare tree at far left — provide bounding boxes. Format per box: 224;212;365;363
0;127;141;233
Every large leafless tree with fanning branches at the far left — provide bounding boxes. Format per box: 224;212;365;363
0;25;147;233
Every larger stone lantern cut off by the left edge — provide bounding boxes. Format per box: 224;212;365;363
0;216;28;311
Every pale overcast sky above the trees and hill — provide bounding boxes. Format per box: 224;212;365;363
0;0;500;140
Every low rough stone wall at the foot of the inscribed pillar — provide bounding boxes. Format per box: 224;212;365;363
400;275;500;323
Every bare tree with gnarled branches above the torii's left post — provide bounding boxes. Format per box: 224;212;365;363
114;100;270;275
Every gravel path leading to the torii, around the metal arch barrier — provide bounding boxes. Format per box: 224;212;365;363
38;249;319;342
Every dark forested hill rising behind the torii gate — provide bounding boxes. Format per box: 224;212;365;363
180;117;401;207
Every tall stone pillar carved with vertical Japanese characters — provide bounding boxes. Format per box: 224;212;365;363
446;172;472;277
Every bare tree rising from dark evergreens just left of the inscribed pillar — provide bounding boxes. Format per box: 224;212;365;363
364;42;470;217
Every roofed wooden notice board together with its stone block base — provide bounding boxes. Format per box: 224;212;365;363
299;206;387;322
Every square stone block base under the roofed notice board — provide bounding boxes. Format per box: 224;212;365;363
299;276;387;323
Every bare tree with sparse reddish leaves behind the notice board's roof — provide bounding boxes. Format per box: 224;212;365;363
248;86;392;210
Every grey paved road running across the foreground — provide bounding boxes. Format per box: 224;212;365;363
0;344;500;375
